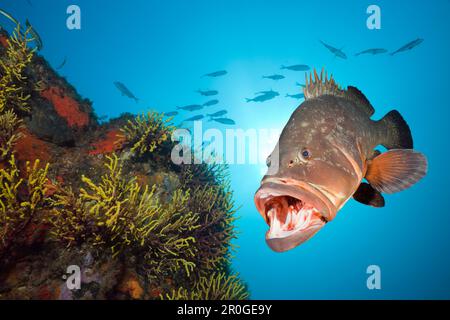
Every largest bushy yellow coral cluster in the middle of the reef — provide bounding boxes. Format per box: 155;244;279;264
50;154;199;276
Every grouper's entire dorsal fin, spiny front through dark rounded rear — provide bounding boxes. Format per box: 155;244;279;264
303;69;375;117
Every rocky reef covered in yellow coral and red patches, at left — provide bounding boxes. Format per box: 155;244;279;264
0;26;249;299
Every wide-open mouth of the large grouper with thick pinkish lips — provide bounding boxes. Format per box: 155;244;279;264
255;178;334;252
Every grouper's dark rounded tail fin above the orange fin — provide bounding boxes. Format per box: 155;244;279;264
379;110;413;149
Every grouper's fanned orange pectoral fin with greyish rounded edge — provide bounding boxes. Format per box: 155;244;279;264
365;149;428;193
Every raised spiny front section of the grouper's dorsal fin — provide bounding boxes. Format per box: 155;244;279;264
303;69;345;100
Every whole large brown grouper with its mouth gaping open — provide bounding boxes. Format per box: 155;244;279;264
255;71;427;252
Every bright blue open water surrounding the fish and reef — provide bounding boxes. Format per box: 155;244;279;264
4;0;450;299
